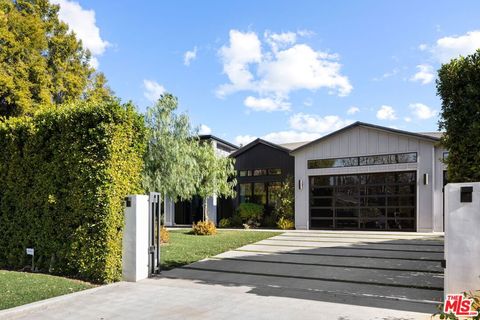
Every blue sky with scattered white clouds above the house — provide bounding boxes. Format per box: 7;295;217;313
54;0;480;144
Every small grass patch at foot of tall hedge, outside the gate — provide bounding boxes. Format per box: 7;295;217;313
0;270;94;310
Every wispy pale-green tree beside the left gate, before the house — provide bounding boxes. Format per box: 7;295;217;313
143;93;236;218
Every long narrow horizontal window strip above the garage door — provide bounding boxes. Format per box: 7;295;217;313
307;152;417;169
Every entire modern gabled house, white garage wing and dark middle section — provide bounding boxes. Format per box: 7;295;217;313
165;122;448;232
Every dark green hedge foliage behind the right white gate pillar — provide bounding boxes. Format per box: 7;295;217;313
437;50;480;182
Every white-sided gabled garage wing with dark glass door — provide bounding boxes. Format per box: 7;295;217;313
291;122;447;232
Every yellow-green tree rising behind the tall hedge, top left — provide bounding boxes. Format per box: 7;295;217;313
0;0;111;117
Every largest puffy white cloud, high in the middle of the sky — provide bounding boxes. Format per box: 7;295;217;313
217;30;352;111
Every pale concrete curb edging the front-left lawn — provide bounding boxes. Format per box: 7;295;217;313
0;281;123;319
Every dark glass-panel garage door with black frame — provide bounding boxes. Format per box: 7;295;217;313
310;171;417;231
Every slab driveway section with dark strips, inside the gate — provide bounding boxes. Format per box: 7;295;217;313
163;231;443;314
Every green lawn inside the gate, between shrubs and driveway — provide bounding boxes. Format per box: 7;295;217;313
161;230;281;270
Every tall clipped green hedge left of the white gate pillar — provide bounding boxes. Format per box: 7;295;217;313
0;102;145;282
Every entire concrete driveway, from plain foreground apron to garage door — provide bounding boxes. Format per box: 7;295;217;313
0;231;443;320
